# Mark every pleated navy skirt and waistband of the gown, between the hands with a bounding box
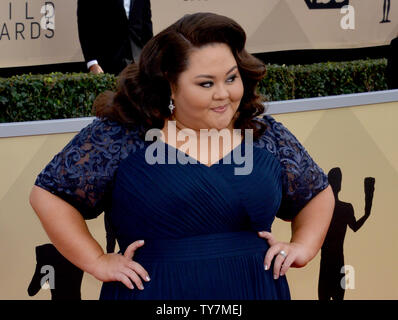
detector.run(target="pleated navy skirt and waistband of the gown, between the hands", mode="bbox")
[100,231,290,300]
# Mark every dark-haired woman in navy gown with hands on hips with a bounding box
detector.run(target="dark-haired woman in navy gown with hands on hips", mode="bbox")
[30,13,334,300]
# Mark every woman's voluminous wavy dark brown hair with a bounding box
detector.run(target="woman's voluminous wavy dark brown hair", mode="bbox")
[94,13,266,139]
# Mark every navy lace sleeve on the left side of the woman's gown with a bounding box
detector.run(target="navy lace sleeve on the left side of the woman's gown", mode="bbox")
[35,119,143,219]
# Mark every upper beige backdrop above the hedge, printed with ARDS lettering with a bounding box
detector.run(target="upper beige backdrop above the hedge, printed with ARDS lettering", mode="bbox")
[0,0,398,68]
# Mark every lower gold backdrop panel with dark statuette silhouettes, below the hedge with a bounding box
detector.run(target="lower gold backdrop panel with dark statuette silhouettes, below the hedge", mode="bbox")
[0,102,398,300]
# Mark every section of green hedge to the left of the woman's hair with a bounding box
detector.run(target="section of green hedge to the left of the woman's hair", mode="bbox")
[0,73,116,122]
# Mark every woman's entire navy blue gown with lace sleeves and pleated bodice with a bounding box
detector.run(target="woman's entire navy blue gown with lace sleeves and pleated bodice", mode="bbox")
[35,116,328,300]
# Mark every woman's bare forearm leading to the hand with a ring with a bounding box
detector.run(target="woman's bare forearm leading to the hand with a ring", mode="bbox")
[291,186,335,261]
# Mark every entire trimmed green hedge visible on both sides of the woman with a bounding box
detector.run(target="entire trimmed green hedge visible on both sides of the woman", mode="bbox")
[0,59,387,122]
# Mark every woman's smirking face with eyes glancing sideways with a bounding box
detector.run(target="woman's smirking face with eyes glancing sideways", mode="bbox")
[171,43,243,130]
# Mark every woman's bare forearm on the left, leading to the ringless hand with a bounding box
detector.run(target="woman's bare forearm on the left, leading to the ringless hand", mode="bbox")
[30,186,104,274]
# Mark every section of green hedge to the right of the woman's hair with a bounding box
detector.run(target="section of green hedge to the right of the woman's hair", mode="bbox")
[260,59,388,101]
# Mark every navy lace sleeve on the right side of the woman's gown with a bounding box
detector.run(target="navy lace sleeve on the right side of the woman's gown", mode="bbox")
[263,116,329,221]
